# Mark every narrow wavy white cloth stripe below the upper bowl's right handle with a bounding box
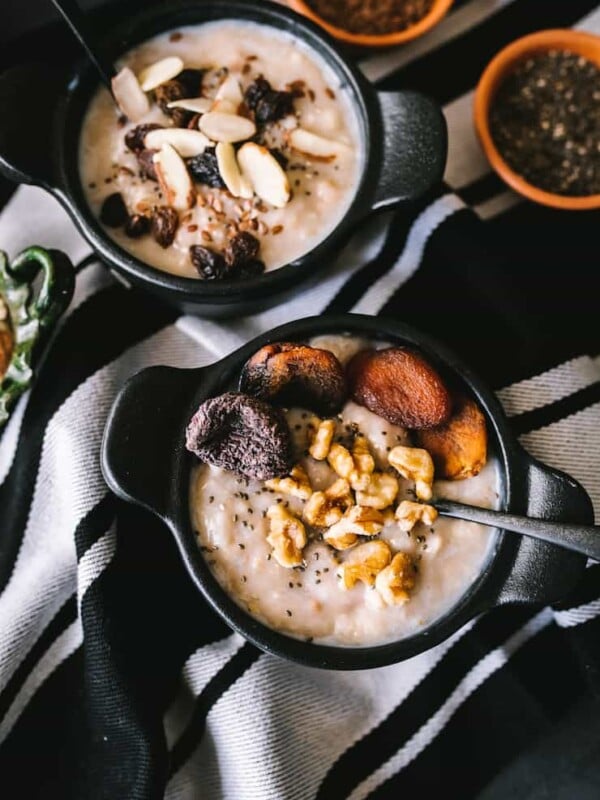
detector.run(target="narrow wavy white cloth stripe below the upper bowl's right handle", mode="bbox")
[352,194,465,314]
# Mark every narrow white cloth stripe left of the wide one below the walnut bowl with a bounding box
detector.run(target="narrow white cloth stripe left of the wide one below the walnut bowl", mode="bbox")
[164,633,245,752]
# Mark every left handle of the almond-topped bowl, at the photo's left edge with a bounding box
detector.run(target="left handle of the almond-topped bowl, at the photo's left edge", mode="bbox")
[0,64,63,190]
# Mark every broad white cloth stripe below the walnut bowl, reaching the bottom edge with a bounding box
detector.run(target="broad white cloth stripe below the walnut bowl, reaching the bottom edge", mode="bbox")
[167,621,474,800]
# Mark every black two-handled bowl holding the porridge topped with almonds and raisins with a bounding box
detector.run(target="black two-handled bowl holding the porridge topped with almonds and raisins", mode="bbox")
[0,0,447,317]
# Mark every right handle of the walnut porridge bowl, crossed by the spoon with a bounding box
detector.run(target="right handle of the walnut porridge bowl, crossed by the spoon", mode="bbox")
[498,451,594,605]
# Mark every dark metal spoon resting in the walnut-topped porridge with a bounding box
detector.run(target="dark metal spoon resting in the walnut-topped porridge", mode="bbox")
[434,500,600,561]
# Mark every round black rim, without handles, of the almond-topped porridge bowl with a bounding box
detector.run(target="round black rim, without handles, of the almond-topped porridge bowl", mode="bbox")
[56,0,382,305]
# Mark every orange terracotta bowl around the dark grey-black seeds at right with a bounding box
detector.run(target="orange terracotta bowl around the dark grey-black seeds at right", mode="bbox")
[474,29,600,211]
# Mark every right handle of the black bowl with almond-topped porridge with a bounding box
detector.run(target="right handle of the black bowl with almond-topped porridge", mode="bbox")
[372,91,448,211]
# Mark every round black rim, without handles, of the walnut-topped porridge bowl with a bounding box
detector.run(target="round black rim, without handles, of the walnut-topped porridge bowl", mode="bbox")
[165,314,519,670]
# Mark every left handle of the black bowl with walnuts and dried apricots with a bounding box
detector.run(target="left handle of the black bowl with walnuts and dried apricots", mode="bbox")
[101,367,200,519]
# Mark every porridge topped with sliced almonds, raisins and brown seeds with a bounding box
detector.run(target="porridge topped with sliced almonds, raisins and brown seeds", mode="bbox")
[79,21,362,280]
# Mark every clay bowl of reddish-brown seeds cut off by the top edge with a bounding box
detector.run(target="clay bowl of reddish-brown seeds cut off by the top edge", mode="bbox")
[289,0,453,47]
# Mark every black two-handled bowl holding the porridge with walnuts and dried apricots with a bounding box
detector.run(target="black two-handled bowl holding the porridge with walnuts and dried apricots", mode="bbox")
[102,314,594,669]
